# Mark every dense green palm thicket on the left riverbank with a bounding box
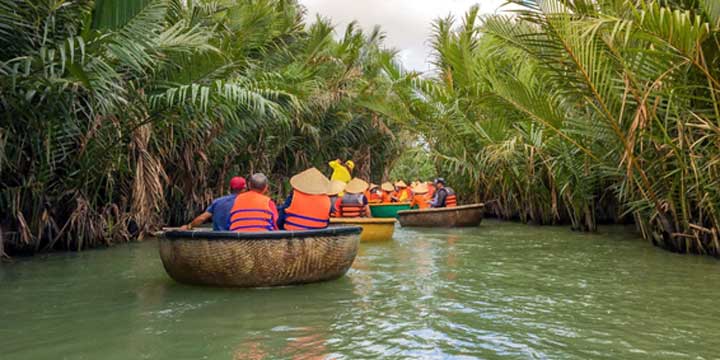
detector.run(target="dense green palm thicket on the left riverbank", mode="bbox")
[0,0,414,256]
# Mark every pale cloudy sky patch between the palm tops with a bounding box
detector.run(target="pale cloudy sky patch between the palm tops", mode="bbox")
[300,0,506,71]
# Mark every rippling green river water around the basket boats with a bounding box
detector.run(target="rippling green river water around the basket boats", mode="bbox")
[0,221,720,360]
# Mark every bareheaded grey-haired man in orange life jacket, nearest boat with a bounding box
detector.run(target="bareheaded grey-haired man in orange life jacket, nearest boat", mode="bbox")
[228,173,278,232]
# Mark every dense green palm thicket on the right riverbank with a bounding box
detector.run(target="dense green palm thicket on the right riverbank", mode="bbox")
[401,0,720,255]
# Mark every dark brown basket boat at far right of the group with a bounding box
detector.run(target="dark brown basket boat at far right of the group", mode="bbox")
[398,204,485,227]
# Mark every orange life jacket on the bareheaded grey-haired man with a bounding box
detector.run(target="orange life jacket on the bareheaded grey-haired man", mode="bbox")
[228,191,275,232]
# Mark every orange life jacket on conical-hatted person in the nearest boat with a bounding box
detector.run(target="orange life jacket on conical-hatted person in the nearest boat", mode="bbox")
[285,190,330,230]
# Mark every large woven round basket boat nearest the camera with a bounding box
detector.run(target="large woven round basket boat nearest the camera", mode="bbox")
[160,226,362,287]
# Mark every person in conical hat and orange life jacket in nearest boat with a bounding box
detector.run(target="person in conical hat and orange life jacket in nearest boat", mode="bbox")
[280,168,332,231]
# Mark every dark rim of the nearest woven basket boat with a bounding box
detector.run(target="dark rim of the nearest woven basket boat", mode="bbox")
[162,226,362,240]
